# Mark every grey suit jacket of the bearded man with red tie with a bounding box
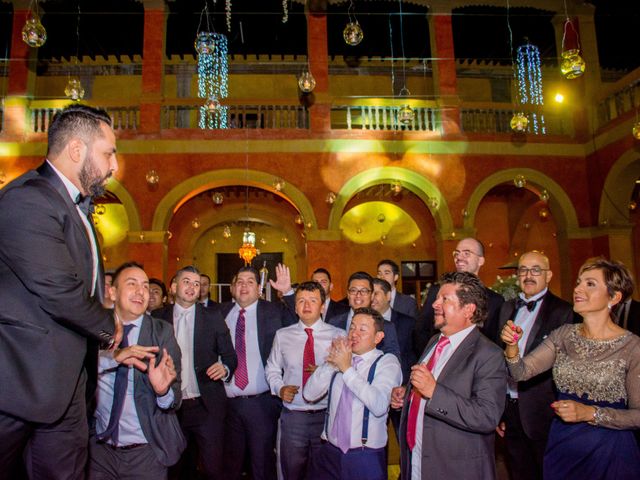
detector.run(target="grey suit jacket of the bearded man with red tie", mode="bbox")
[400,328,507,480]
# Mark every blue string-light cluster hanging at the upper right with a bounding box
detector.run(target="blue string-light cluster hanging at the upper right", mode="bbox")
[516,43,547,135]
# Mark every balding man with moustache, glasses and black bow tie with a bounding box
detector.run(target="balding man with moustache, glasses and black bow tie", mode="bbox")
[492,251,575,480]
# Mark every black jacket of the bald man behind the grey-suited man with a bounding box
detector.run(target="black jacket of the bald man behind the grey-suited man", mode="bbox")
[414,284,504,353]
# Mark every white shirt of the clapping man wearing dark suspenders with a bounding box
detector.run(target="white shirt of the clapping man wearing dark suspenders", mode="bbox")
[304,349,402,448]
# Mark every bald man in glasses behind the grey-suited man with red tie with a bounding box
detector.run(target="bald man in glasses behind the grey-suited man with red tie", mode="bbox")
[415,238,504,352]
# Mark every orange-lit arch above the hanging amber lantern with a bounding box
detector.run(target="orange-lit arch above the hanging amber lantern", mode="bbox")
[151,169,318,231]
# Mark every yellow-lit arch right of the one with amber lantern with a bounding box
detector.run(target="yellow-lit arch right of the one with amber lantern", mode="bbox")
[328,167,453,236]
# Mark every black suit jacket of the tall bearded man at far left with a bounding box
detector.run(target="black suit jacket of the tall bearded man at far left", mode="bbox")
[0,163,114,423]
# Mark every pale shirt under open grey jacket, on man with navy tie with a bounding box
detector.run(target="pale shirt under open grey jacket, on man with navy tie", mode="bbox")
[95,316,175,446]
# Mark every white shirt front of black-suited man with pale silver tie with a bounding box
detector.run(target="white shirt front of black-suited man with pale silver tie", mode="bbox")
[173,303,200,400]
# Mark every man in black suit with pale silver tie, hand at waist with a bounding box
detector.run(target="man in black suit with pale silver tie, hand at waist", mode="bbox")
[152,266,237,479]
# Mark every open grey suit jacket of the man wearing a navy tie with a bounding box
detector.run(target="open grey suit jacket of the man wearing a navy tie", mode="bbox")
[133,315,187,467]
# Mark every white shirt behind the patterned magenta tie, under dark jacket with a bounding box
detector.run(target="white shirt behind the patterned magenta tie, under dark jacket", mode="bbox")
[224,300,269,398]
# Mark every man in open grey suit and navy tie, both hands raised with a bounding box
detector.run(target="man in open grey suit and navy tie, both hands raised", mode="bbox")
[89,263,186,480]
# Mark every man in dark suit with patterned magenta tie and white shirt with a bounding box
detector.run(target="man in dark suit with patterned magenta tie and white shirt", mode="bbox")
[220,267,296,480]
